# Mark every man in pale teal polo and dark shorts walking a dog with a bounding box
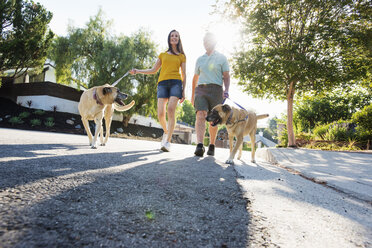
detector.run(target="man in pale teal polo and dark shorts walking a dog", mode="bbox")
[191,32,230,157]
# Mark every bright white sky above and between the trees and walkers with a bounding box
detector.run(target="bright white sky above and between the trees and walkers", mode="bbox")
[35,0,286,125]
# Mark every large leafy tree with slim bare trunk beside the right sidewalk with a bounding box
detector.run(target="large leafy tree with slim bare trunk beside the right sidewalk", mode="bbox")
[218,0,371,146]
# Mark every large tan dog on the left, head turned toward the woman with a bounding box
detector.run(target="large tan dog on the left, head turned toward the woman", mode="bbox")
[78,84,134,149]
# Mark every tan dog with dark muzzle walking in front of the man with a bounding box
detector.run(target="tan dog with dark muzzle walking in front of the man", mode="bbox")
[206,104,269,164]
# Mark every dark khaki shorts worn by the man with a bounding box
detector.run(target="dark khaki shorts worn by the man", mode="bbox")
[194,84,223,112]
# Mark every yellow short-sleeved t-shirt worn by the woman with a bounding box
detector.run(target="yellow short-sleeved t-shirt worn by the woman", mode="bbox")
[158,52,186,83]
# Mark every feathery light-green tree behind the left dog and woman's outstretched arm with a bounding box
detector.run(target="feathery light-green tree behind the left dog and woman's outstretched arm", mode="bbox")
[49,10,157,118]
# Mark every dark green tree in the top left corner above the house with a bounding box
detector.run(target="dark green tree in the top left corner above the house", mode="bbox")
[0,0,54,83]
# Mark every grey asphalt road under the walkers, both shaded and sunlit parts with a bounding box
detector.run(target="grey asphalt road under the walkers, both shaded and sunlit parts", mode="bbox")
[0,129,372,247]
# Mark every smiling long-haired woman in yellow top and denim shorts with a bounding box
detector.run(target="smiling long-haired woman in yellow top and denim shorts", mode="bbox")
[130,30,186,152]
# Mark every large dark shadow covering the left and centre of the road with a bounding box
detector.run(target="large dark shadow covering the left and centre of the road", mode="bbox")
[0,145,249,247]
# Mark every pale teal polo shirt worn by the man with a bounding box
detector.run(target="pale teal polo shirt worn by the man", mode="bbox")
[195,51,230,86]
